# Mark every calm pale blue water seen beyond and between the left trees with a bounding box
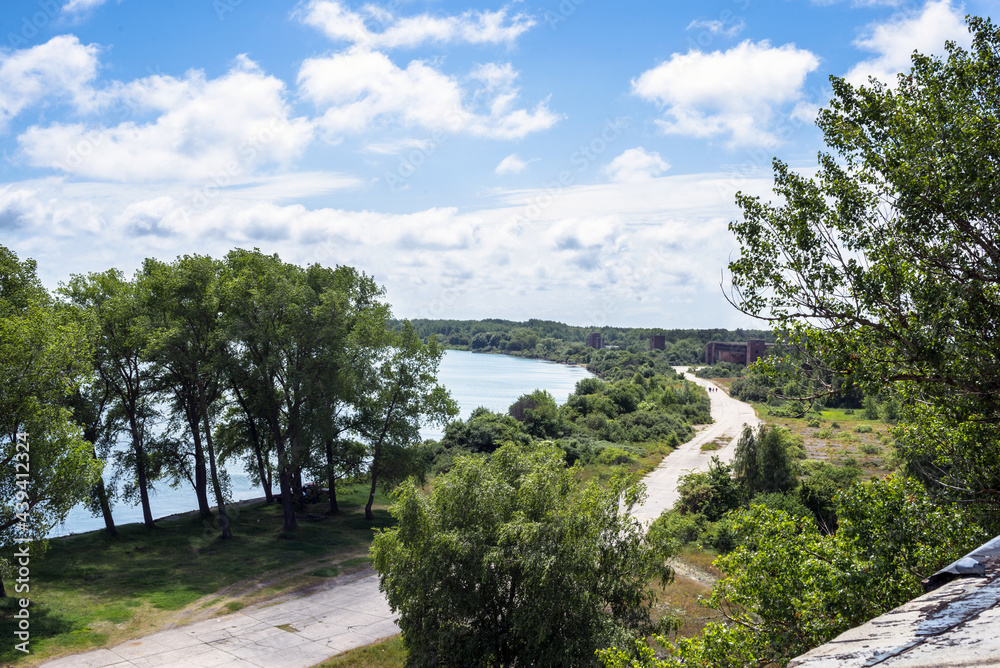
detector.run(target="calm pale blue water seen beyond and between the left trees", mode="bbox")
[51,350,592,536]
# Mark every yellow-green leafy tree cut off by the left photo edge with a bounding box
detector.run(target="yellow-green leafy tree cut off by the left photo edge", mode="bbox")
[0,246,101,597]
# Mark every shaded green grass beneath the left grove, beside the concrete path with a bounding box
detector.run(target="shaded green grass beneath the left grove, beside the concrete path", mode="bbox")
[0,485,392,666]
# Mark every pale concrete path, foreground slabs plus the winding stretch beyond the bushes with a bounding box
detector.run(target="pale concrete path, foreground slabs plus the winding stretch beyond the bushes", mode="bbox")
[42,367,757,668]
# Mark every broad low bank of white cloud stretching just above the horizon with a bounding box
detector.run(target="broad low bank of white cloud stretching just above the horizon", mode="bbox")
[11,167,772,327]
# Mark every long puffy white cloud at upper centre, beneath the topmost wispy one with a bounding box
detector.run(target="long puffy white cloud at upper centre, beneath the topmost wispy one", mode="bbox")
[298,47,560,141]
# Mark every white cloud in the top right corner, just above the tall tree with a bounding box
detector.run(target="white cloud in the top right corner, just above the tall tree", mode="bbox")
[844,0,972,85]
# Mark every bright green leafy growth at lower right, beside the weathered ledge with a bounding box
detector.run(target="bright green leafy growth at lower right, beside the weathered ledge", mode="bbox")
[602,477,989,668]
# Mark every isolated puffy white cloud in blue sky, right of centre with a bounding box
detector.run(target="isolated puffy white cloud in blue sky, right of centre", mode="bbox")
[632,40,819,146]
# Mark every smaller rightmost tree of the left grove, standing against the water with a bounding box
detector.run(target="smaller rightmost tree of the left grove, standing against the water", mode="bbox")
[354,322,458,520]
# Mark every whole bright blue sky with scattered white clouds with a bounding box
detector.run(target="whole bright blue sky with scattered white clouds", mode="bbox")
[0,0,997,328]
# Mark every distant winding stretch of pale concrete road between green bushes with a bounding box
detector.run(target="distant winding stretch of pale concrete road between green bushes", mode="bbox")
[634,367,760,524]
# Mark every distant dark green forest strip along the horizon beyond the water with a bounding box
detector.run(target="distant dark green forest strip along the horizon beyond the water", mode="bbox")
[398,318,774,365]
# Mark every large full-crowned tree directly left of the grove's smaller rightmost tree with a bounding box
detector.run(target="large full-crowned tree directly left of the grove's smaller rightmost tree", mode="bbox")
[220,250,395,530]
